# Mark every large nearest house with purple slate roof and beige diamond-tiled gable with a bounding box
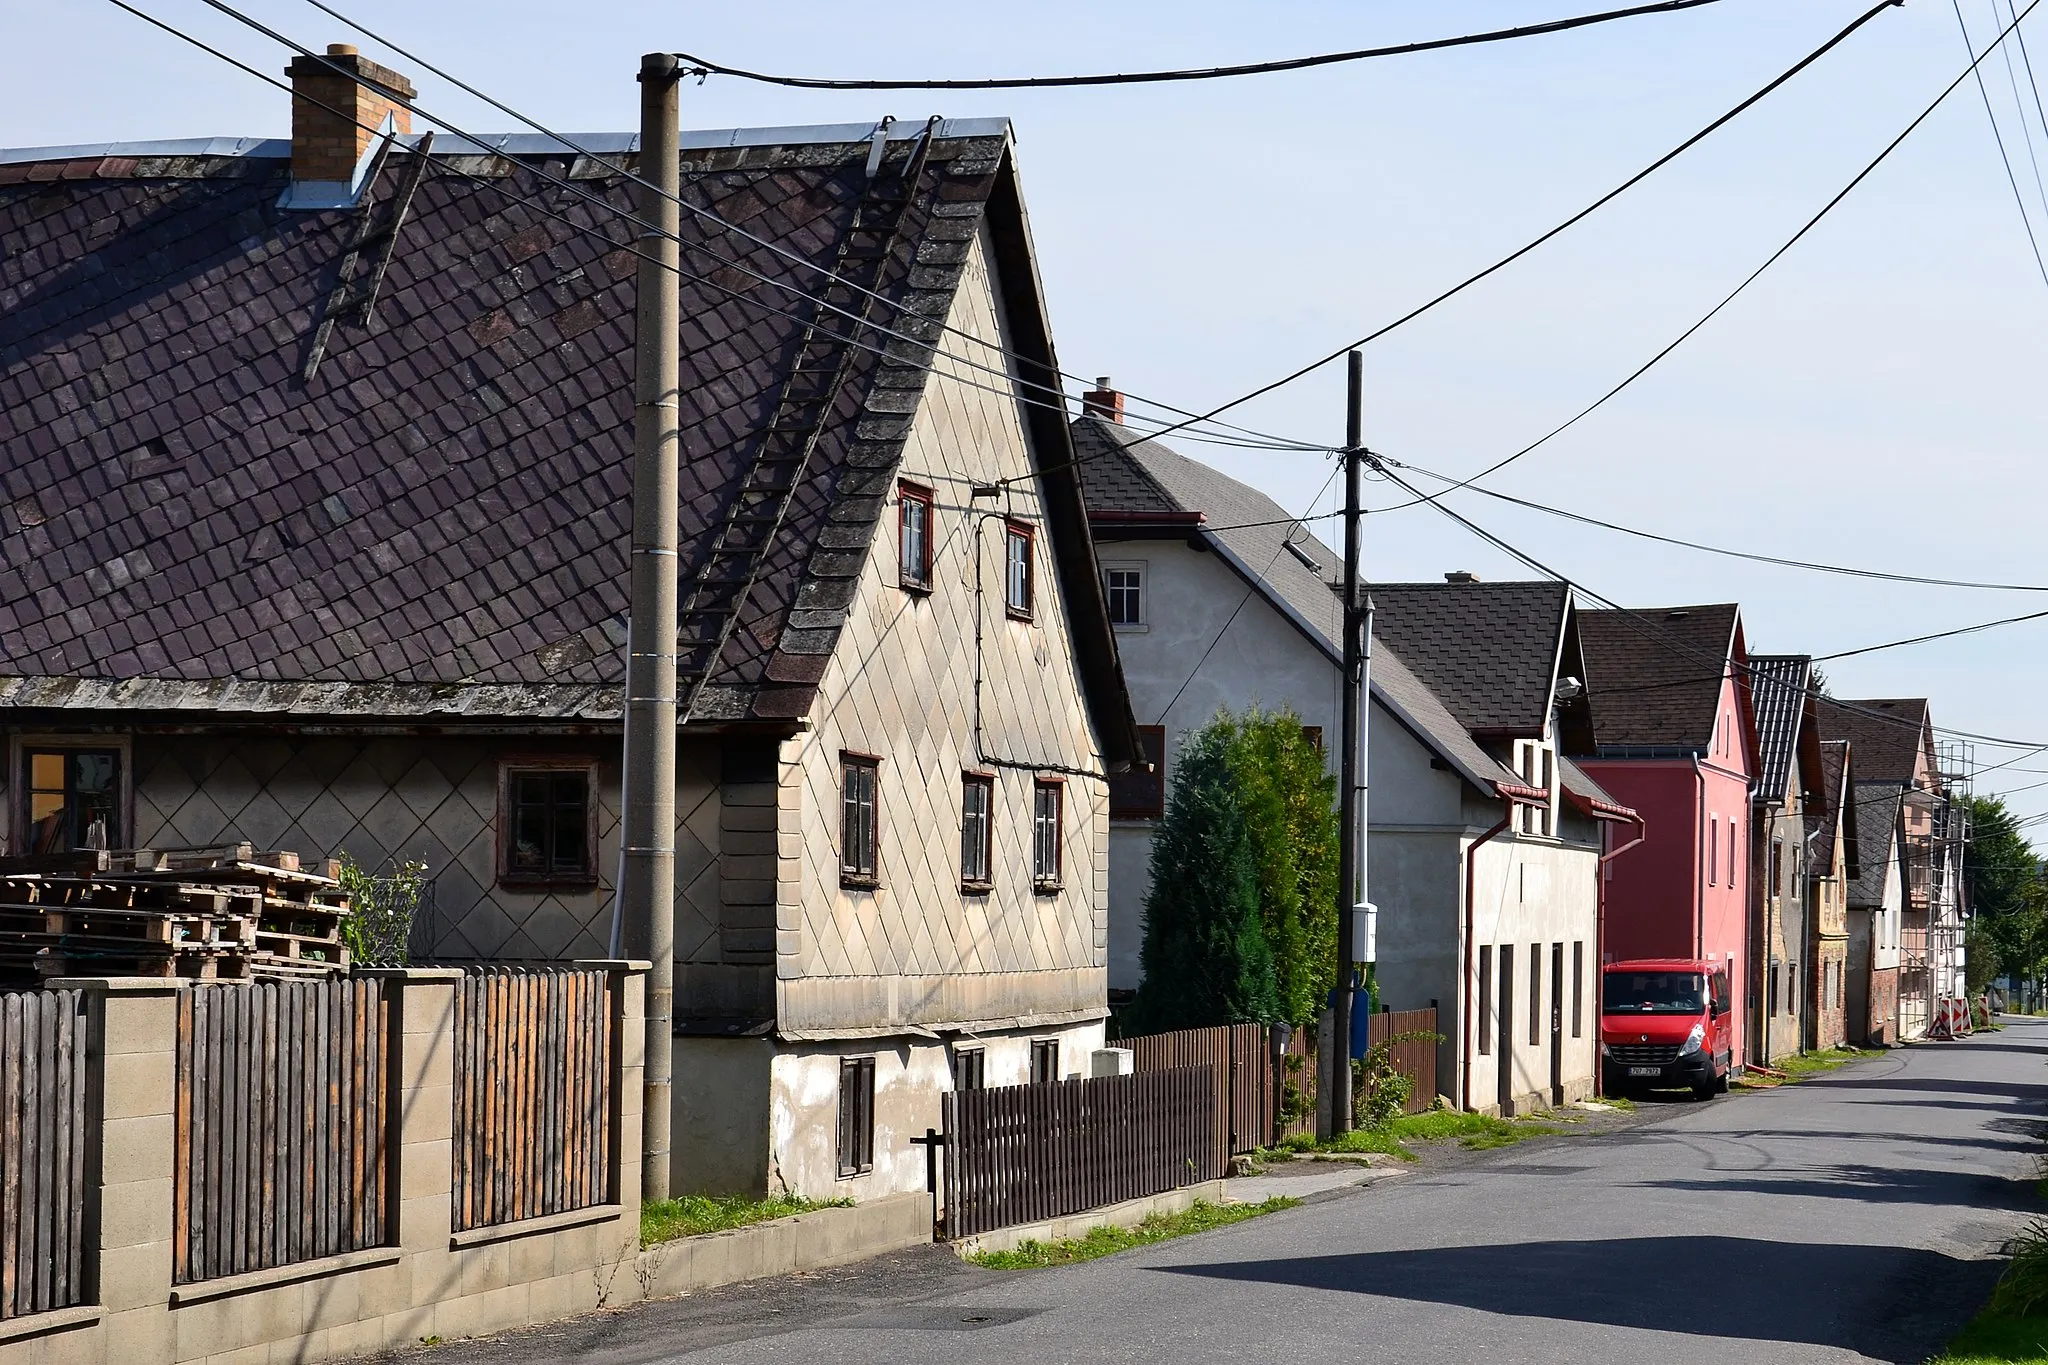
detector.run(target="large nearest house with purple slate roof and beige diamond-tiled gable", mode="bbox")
[0,49,1137,1199]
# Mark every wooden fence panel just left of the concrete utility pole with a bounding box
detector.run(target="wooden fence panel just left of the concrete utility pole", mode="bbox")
[455,968,612,1230]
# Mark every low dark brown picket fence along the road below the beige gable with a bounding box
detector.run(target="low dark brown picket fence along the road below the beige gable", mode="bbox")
[940,1066,1217,1238]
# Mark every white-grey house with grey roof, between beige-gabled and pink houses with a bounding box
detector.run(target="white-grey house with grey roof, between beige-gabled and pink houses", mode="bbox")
[1073,401,1634,1113]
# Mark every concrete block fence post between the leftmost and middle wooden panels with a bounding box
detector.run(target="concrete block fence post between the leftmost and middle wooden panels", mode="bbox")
[45,976,186,1365]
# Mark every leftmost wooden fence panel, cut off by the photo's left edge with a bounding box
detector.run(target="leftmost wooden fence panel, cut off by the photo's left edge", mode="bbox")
[0,990,92,1318]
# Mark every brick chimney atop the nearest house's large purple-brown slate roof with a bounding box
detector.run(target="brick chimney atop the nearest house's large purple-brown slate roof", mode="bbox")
[285,43,418,209]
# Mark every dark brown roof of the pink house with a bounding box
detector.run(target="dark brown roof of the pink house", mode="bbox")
[1579,604,1741,753]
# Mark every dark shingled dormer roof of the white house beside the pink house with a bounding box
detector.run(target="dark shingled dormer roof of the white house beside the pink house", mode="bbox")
[1372,581,1571,737]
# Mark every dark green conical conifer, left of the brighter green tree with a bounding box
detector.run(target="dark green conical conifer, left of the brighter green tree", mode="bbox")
[1130,718,1280,1031]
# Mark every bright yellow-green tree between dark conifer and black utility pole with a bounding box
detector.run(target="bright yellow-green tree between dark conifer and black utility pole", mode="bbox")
[1212,706,1337,1025]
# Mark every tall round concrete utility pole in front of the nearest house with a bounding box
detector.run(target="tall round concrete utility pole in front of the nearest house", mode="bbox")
[618,53,682,1199]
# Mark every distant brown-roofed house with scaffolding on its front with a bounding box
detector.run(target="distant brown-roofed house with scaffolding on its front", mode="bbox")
[1823,698,1966,1040]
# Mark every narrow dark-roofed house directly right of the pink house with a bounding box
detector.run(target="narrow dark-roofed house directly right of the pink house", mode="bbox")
[1747,655,1823,1064]
